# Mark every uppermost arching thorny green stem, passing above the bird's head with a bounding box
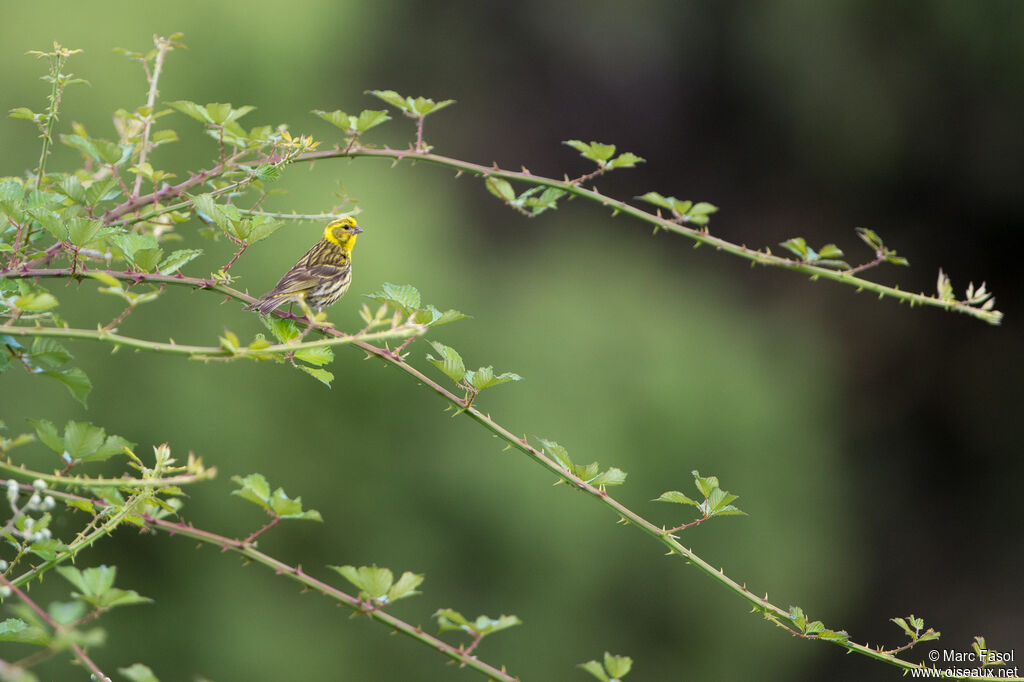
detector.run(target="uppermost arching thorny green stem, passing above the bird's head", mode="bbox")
[295,146,1002,325]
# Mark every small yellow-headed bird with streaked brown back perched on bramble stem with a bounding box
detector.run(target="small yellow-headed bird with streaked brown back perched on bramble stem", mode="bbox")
[243,216,362,317]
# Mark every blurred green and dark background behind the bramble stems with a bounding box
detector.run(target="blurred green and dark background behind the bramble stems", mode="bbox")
[0,0,1024,680]
